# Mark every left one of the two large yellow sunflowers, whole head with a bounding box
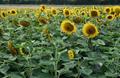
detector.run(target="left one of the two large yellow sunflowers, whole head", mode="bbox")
[61,20,77,34]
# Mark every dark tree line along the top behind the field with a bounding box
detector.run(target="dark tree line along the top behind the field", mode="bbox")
[0,0,120,5]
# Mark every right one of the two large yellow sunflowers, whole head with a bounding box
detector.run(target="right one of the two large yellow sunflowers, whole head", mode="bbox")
[82,22,99,38]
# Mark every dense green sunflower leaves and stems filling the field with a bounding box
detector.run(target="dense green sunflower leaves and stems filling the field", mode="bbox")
[0,6,120,78]
